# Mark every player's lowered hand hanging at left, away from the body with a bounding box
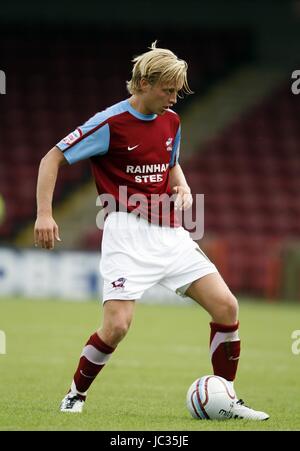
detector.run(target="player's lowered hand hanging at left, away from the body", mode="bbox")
[34,216,61,249]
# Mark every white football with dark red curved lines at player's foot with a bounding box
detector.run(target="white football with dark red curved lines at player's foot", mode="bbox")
[186,375,236,420]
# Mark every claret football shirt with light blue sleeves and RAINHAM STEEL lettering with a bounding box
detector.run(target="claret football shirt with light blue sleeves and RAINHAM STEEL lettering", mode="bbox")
[57,100,180,226]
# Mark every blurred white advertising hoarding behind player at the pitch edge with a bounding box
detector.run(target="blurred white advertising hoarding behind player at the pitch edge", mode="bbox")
[0,248,186,304]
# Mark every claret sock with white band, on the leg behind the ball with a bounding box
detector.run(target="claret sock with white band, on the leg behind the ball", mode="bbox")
[210,322,240,381]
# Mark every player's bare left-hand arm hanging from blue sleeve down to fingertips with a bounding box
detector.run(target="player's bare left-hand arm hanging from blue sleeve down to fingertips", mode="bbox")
[34,147,67,249]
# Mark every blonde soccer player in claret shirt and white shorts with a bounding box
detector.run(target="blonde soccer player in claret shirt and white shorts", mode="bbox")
[34,42,269,420]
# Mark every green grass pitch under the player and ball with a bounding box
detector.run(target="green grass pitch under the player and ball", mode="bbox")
[0,298,300,431]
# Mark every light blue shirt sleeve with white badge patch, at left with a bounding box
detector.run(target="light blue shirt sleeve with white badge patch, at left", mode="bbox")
[56,113,110,164]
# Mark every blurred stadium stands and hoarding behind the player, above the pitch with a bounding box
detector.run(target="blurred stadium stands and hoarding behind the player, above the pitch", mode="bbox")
[0,0,300,302]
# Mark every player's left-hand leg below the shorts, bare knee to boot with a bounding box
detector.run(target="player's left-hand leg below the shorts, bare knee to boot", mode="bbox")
[60,300,135,412]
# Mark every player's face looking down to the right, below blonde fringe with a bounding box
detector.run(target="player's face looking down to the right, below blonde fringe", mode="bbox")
[143,83,178,115]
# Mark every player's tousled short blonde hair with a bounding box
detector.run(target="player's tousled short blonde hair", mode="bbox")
[126,41,193,94]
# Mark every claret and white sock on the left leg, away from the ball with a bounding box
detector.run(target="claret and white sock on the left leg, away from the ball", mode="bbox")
[70,332,115,400]
